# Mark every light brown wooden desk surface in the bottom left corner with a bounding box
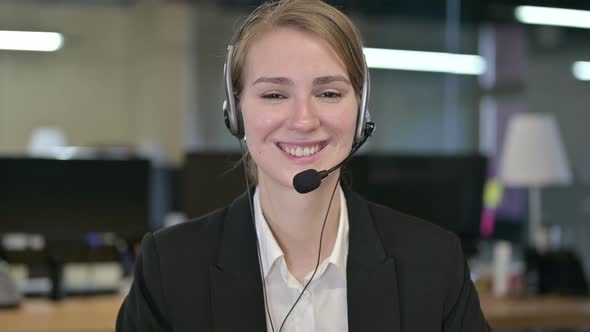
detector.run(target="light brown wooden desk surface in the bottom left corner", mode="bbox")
[0,295,124,332]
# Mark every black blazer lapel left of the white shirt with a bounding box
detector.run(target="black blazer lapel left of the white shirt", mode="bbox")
[209,193,266,332]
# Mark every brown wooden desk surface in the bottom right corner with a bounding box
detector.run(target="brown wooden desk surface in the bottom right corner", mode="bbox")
[480,295,590,329]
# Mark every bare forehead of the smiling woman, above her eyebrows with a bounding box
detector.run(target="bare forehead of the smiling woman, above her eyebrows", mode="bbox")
[244,27,348,82]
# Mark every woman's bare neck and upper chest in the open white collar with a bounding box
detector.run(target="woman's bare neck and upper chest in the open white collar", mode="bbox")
[258,171,340,279]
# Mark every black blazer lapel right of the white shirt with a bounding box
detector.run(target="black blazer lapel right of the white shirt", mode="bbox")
[345,190,400,332]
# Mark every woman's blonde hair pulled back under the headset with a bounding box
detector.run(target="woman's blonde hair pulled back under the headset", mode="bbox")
[228,0,366,183]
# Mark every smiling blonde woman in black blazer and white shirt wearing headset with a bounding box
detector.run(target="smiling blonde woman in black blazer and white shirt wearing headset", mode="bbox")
[117,0,489,332]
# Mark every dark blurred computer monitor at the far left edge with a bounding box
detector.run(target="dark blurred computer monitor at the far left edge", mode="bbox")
[0,157,150,243]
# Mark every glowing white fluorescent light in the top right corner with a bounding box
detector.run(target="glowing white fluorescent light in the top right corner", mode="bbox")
[514,6,590,29]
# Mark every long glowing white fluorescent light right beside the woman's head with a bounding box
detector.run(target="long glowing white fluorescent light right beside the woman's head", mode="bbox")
[363,47,486,75]
